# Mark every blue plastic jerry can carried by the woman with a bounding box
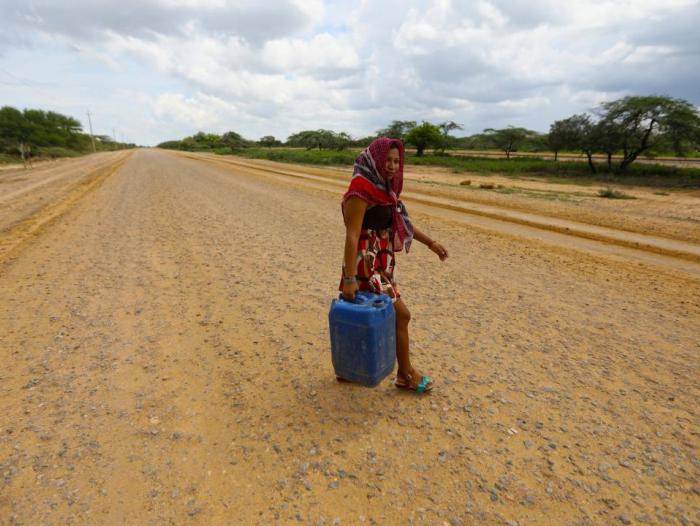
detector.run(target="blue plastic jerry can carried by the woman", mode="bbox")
[328,292,396,387]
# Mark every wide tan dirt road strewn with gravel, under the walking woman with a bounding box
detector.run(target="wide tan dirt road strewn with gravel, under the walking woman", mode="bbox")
[0,150,700,526]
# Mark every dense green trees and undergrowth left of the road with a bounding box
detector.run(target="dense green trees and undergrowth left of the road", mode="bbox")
[0,106,136,164]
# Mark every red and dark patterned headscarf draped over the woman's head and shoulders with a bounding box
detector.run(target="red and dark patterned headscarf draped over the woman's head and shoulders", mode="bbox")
[343,137,413,252]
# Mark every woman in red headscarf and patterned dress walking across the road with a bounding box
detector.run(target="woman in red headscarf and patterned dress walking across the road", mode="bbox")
[340,137,448,393]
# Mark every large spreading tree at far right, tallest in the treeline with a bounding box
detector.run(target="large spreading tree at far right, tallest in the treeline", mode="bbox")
[602,95,700,172]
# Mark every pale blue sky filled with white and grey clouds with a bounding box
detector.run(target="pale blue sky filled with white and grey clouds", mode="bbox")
[0,0,700,145]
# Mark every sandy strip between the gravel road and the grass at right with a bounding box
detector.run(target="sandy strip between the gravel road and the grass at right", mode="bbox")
[212,154,700,243]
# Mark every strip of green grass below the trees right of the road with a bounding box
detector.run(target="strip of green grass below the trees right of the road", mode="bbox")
[230,148,700,188]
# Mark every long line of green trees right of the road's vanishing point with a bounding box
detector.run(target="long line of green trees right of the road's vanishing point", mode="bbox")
[158,96,700,173]
